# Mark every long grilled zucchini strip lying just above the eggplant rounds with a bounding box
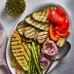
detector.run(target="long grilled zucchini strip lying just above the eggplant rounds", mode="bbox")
[25,16,49,31]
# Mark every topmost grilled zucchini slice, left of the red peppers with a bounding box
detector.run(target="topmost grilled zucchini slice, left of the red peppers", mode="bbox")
[32,6,56,23]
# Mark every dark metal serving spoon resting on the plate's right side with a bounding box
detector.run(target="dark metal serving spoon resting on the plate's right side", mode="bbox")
[44,41,71,74]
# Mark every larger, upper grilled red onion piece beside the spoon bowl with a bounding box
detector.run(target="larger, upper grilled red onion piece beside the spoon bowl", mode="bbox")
[42,40,58,59]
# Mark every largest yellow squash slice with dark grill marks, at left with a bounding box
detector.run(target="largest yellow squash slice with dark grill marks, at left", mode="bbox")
[11,31,29,71]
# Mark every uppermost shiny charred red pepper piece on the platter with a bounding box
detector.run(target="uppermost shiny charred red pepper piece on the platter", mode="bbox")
[48,10,69,26]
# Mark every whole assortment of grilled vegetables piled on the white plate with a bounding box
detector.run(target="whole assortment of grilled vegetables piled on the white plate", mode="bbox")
[6,5,70,74]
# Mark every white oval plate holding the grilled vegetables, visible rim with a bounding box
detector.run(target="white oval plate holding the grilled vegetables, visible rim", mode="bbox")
[6,2,71,74]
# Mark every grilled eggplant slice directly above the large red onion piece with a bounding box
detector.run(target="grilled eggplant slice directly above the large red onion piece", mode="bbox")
[37,31,48,43]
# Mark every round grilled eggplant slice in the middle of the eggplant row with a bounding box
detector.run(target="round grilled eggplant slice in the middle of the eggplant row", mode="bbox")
[24,26,36,39]
